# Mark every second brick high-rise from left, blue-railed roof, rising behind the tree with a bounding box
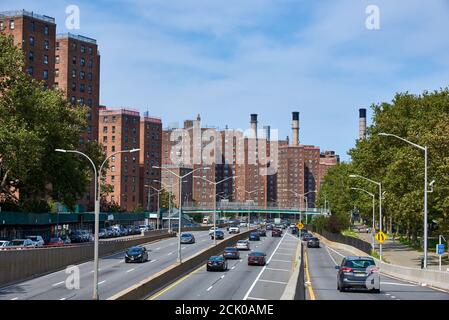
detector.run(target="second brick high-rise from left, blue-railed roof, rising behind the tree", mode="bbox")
[54,33,100,144]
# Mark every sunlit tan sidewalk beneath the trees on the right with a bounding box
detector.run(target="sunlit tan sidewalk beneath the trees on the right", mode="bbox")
[357,233,449,271]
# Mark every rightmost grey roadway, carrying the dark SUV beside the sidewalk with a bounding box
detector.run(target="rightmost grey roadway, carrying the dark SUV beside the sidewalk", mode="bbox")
[305,243,449,300]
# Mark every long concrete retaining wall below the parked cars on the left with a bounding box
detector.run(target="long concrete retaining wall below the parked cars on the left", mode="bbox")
[0,230,175,286]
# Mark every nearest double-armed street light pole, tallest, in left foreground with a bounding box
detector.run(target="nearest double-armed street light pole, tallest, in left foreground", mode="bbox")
[55,149,140,300]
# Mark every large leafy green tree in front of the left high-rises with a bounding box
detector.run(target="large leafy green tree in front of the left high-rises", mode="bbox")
[0,34,105,212]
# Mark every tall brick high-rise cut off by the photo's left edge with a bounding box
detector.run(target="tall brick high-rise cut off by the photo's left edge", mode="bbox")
[0,10,56,88]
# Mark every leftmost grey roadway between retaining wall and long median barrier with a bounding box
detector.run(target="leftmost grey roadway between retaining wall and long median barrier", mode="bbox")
[0,228,236,300]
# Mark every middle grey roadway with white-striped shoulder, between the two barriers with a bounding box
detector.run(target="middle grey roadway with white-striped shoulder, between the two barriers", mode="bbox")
[149,231,299,300]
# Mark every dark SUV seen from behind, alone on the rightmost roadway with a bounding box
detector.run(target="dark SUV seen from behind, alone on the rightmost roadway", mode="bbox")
[335,256,380,293]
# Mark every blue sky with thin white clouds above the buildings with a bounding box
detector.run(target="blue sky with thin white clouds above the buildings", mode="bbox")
[0,0,449,161]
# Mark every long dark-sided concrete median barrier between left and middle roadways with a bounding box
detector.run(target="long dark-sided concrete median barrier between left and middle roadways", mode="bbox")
[108,229,255,300]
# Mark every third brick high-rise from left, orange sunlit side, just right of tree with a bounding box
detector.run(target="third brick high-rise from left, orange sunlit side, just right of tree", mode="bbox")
[99,108,143,211]
